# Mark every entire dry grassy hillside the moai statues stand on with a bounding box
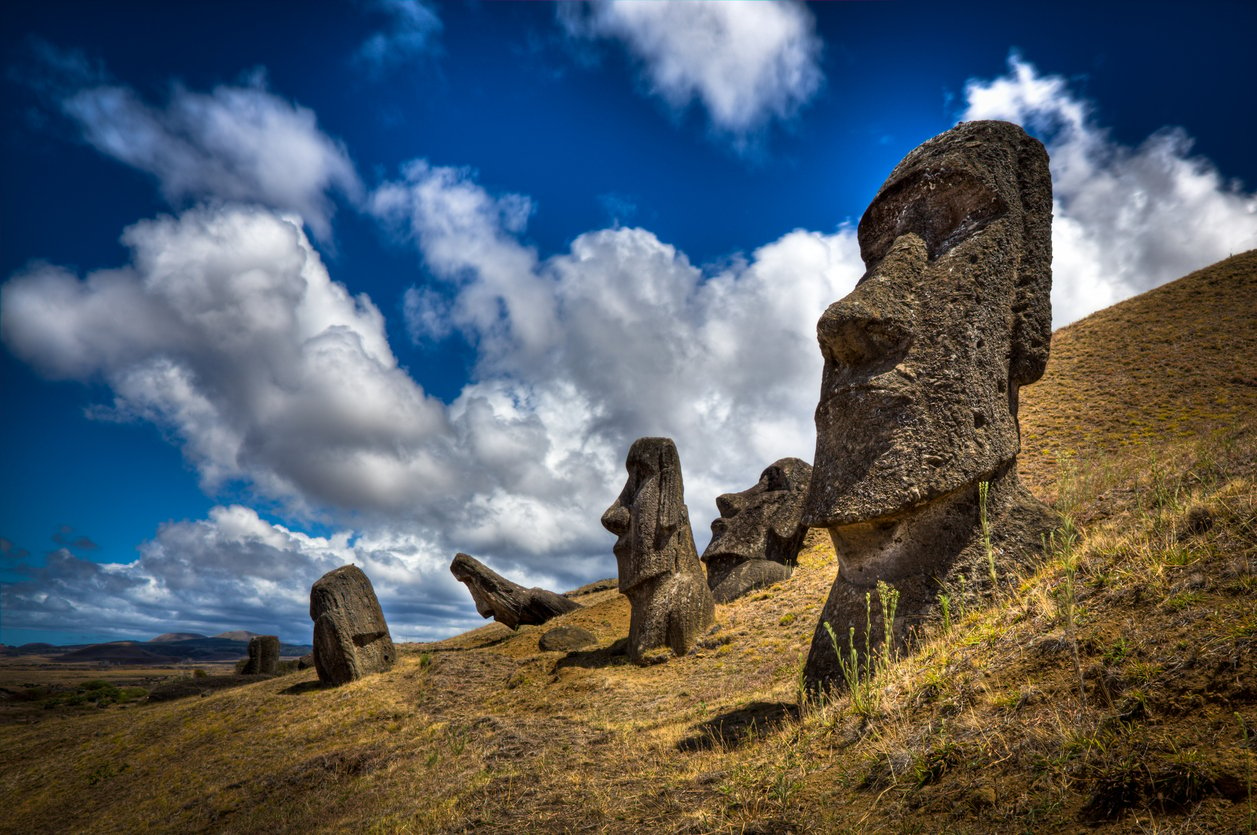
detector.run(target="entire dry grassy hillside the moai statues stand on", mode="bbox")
[0,253,1257,832]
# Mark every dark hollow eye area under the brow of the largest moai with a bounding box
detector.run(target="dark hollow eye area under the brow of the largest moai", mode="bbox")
[859,170,1008,267]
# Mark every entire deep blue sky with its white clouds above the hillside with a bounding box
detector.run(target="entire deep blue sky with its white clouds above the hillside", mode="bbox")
[0,0,1257,644]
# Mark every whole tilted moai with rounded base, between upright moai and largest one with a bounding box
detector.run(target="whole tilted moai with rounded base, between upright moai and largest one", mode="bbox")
[703,458,812,604]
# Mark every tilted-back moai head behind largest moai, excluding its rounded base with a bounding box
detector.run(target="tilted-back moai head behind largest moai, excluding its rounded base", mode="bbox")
[703,458,812,570]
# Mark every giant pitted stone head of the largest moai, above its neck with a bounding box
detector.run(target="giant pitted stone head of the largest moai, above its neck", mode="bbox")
[803,122,1052,529]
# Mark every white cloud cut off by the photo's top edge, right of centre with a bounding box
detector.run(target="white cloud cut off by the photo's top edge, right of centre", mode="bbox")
[561,0,823,135]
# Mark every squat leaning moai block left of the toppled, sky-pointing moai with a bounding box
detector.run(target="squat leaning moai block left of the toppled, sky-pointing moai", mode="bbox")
[310,566,397,684]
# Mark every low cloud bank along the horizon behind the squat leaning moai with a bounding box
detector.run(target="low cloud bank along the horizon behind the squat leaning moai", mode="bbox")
[0,506,479,643]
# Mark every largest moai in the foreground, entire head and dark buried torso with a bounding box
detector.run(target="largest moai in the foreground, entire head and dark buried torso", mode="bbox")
[803,122,1056,690]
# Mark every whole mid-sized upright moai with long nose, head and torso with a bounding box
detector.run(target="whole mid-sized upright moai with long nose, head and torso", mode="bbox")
[602,438,715,664]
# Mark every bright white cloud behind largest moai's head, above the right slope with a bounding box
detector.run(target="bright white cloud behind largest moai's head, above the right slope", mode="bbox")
[964,54,1257,327]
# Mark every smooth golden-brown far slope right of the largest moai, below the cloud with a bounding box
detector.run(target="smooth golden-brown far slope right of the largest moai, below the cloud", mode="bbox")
[1018,250,1257,499]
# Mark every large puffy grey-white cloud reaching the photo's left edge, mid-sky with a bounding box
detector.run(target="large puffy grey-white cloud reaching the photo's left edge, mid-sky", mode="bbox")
[0,206,449,509]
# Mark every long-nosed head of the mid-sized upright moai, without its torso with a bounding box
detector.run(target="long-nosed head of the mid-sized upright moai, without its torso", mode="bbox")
[602,438,698,591]
